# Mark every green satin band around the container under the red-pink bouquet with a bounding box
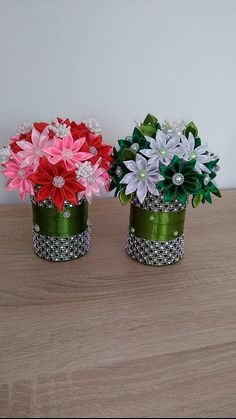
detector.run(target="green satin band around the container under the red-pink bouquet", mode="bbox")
[32,202,88,237]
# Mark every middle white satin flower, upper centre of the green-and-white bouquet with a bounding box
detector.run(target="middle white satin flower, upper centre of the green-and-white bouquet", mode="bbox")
[140,130,182,170]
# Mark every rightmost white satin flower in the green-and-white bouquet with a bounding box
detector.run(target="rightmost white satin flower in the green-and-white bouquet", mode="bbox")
[180,132,215,173]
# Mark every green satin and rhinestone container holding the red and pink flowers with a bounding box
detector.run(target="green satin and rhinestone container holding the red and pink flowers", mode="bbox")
[32,199,91,262]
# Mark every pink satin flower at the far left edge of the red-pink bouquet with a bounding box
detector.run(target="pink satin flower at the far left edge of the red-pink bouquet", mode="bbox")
[2,152,34,199]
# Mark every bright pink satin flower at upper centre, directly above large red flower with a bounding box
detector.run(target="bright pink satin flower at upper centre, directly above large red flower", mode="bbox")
[49,133,93,170]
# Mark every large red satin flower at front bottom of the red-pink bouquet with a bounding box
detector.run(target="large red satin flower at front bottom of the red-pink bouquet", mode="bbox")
[29,158,85,211]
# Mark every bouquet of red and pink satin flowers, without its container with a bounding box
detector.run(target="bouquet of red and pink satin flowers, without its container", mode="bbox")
[0,118,112,211]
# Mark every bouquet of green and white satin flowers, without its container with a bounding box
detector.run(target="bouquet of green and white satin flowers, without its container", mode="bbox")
[109,114,221,207]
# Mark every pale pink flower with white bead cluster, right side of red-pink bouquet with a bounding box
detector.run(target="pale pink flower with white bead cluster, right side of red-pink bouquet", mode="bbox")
[75,159,109,204]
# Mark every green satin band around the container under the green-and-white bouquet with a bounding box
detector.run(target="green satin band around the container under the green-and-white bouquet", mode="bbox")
[130,204,185,241]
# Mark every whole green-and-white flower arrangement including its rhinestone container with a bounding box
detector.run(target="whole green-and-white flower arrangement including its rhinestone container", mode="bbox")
[109,114,221,266]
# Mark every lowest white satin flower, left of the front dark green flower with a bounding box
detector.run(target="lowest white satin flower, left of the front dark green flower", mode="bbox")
[121,154,163,203]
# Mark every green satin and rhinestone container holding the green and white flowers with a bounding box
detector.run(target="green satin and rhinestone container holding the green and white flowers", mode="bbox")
[126,194,186,266]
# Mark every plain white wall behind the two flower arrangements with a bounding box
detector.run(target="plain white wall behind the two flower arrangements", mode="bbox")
[0,0,236,202]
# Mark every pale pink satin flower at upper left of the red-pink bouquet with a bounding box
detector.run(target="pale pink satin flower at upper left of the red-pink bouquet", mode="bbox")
[17,128,52,171]
